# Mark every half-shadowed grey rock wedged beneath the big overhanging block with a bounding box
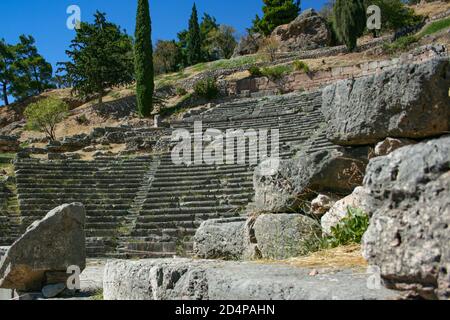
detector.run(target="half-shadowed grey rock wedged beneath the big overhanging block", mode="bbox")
[253,148,368,212]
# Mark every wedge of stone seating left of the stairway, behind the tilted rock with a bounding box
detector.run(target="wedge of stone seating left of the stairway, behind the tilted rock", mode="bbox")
[16,157,152,257]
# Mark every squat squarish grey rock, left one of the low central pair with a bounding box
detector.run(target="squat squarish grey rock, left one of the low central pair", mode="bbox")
[194,217,246,260]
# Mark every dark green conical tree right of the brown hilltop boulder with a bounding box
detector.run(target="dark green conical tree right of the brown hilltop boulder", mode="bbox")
[333,0,366,51]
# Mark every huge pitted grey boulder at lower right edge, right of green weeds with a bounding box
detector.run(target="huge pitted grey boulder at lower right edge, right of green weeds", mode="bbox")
[363,136,450,299]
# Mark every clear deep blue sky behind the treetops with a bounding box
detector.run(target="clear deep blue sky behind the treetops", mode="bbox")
[0,0,325,69]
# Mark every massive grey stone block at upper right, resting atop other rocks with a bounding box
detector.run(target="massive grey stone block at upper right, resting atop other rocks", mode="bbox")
[322,58,450,145]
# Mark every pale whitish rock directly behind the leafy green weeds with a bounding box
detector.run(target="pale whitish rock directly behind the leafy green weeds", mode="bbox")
[321,187,368,234]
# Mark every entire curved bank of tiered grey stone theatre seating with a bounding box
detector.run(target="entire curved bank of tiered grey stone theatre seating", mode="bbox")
[4,92,333,258]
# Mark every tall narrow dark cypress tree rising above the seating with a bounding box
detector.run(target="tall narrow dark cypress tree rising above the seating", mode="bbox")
[134,0,155,117]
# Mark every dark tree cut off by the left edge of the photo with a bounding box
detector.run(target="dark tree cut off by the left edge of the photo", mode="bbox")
[0,39,15,106]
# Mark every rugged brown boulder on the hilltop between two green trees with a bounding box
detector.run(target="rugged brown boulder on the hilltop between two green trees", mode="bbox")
[271,9,332,52]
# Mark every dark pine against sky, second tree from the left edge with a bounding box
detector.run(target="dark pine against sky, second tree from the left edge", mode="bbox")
[11,35,55,100]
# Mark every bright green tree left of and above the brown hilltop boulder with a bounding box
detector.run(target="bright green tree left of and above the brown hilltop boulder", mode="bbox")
[252,0,300,36]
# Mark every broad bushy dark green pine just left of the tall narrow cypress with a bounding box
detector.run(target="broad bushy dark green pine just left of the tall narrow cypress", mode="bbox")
[58,11,134,103]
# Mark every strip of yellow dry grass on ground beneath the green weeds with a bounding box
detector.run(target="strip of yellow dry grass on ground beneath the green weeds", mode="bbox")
[258,245,367,269]
